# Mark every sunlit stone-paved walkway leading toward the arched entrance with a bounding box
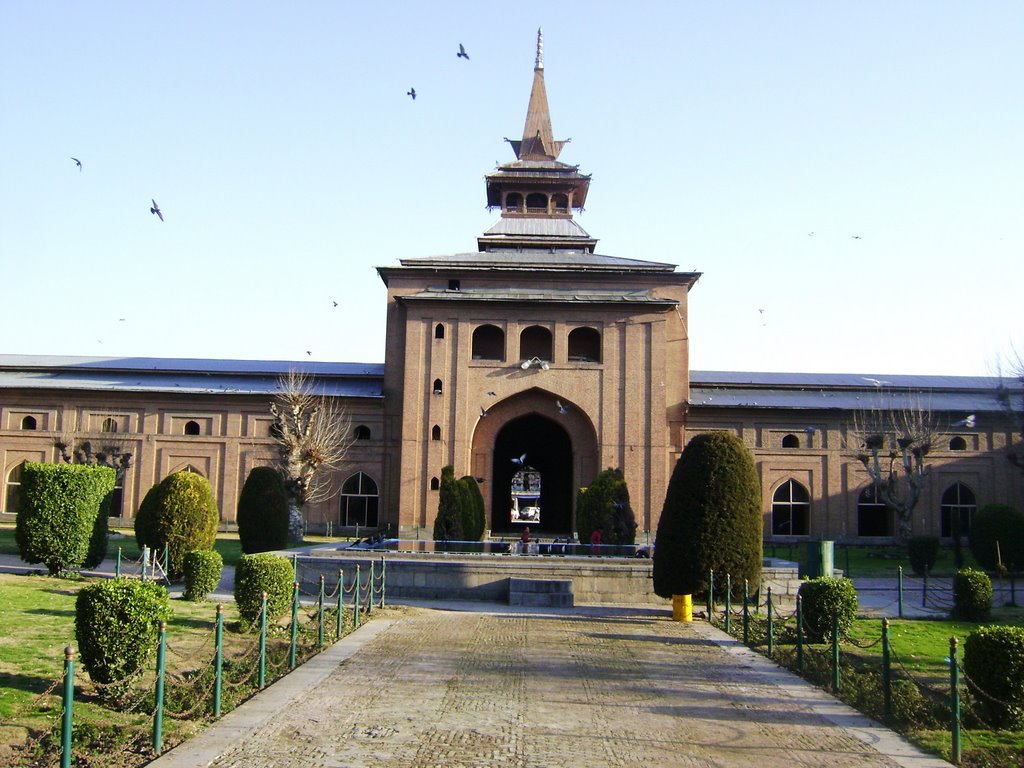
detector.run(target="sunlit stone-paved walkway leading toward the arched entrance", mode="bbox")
[152,604,948,768]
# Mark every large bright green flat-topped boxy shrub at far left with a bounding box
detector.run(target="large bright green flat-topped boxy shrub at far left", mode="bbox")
[14,463,117,574]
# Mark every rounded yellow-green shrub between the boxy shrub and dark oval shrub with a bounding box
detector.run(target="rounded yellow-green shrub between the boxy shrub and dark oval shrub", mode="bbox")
[135,470,220,579]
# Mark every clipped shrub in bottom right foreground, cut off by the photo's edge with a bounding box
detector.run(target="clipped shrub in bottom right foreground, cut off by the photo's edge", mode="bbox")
[964,627,1024,729]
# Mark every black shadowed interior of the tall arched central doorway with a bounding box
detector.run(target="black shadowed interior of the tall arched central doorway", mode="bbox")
[490,414,575,536]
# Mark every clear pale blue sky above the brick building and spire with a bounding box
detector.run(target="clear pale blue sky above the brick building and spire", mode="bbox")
[0,0,1024,375]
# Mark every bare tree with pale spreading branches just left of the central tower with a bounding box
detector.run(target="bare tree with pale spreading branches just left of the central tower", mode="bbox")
[270,370,353,542]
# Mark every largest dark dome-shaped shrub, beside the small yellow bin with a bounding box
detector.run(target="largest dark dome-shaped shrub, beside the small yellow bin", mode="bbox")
[654,432,763,597]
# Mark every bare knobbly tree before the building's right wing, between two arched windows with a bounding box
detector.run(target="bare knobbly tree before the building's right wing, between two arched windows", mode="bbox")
[847,391,945,541]
